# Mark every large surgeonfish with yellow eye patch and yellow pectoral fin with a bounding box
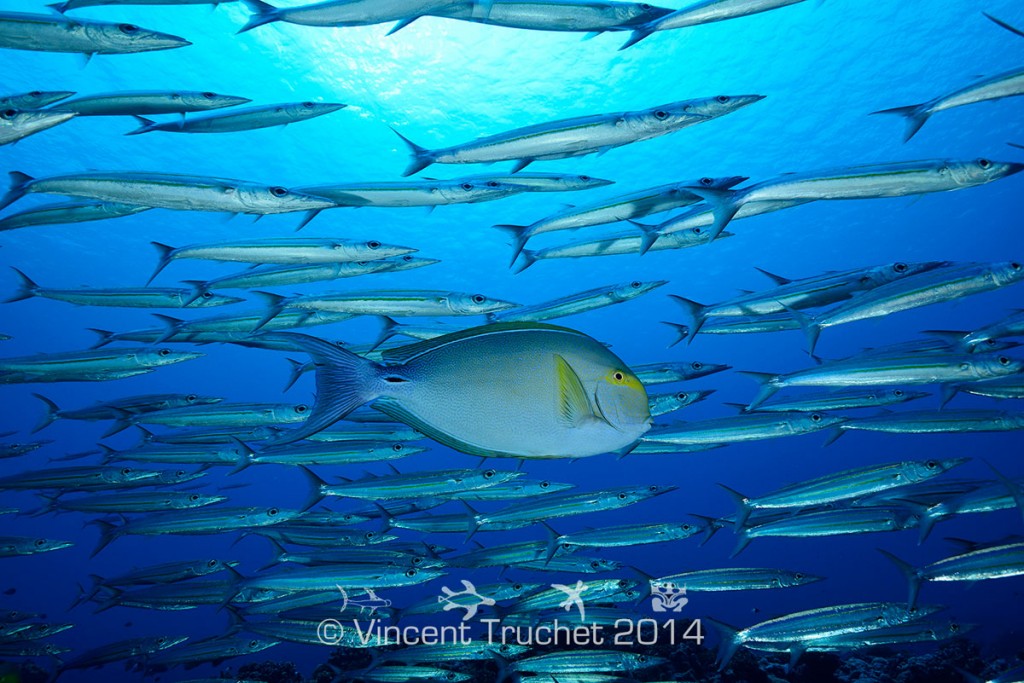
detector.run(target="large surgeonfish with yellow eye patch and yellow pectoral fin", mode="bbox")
[262,323,651,458]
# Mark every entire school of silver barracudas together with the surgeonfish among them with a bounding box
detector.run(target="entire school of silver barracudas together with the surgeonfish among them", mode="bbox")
[0,0,1024,683]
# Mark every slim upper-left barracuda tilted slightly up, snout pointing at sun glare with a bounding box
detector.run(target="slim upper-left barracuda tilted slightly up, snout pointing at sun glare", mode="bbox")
[125,102,348,135]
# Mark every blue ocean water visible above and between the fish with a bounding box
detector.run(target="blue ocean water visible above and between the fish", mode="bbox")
[0,0,1024,681]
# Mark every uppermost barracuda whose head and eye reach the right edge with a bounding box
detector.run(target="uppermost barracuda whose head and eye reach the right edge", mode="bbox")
[690,159,1024,239]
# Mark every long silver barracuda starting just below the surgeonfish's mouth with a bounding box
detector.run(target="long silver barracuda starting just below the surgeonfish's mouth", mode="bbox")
[643,413,848,446]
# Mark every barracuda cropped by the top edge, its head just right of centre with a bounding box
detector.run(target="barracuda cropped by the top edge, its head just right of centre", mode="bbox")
[431,0,672,34]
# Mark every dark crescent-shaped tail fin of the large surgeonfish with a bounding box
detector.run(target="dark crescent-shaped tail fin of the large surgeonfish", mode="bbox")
[260,333,385,445]
